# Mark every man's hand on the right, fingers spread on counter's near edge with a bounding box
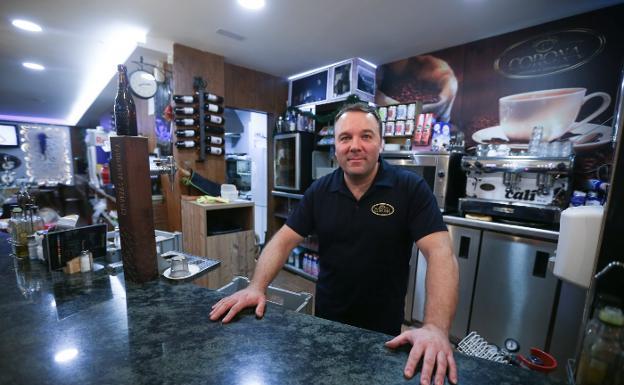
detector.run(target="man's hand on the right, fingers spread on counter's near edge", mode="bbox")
[386,324,457,385]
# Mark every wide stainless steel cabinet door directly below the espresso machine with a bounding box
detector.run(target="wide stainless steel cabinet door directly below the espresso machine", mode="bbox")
[470,231,558,353]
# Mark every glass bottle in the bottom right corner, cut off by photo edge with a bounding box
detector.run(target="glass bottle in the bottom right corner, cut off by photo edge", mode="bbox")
[576,307,624,385]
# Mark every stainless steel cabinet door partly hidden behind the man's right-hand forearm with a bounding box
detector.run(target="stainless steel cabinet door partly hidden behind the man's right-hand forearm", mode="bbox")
[412,225,481,338]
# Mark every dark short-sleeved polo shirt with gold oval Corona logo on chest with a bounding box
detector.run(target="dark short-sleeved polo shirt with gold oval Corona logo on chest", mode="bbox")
[286,160,446,335]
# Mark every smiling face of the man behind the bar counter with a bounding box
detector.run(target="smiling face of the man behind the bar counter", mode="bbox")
[335,111,382,178]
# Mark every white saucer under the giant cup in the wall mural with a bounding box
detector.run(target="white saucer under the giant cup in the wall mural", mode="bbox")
[472,123,612,151]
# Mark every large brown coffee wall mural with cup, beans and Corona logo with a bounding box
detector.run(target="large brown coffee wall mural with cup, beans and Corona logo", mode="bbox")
[375,5,624,154]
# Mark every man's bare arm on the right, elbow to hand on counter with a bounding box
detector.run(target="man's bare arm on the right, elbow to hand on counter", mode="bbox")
[386,231,459,385]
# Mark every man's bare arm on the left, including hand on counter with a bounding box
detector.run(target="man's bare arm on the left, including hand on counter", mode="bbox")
[210,225,303,323]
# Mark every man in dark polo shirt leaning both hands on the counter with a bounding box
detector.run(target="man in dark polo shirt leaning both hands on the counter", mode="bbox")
[210,104,458,385]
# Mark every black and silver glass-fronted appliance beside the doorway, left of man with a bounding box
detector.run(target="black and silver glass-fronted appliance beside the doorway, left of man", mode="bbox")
[273,131,314,194]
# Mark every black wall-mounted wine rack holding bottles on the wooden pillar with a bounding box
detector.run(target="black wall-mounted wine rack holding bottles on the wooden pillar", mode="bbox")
[174,90,225,162]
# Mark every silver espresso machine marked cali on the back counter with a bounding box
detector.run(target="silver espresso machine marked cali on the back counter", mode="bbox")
[459,156,574,227]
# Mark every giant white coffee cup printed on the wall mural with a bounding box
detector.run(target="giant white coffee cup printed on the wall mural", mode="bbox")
[498,88,611,143]
